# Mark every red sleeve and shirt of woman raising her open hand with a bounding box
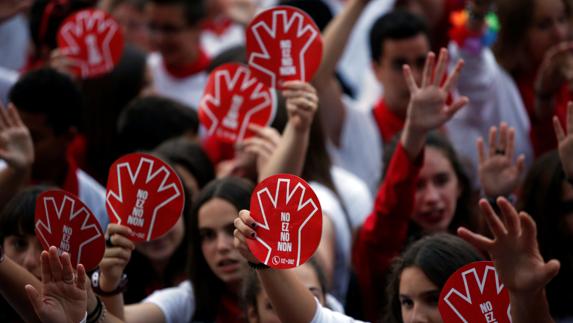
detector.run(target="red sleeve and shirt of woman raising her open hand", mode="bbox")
[352,143,424,322]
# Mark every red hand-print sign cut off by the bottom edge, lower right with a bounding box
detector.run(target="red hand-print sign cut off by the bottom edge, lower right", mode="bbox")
[438,261,511,323]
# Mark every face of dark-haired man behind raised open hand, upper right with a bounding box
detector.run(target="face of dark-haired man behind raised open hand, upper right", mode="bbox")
[373,34,430,117]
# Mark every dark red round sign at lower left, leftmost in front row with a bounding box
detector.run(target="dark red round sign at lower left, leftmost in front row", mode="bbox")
[34,190,105,270]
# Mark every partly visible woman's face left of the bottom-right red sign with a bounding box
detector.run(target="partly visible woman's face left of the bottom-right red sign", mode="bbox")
[399,267,442,323]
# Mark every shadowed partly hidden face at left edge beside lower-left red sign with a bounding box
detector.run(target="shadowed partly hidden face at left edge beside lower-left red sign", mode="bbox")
[2,234,43,279]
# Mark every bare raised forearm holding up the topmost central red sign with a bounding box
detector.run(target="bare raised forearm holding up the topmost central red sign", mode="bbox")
[259,121,310,180]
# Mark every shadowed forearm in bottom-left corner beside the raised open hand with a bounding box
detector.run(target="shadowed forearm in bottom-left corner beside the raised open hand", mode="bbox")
[0,257,42,322]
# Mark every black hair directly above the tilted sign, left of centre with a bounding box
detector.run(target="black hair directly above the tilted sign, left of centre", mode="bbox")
[118,96,199,154]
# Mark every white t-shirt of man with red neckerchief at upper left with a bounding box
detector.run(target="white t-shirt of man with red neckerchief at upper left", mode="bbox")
[147,53,209,110]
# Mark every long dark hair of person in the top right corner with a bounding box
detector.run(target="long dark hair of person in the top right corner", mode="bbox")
[493,0,571,77]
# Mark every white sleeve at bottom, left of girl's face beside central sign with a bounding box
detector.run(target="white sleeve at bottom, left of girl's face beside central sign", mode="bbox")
[143,280,195,323]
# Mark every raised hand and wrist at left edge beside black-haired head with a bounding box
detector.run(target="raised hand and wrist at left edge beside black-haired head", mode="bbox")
[0,104,34,207]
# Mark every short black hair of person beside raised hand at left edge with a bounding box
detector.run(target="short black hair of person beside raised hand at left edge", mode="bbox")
[8,68,82,135]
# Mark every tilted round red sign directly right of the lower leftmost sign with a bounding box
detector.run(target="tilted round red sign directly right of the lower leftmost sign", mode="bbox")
[106,154,185,241]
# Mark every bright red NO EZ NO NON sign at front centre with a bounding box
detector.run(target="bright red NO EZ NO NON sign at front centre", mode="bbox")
[248,174,322,269]
